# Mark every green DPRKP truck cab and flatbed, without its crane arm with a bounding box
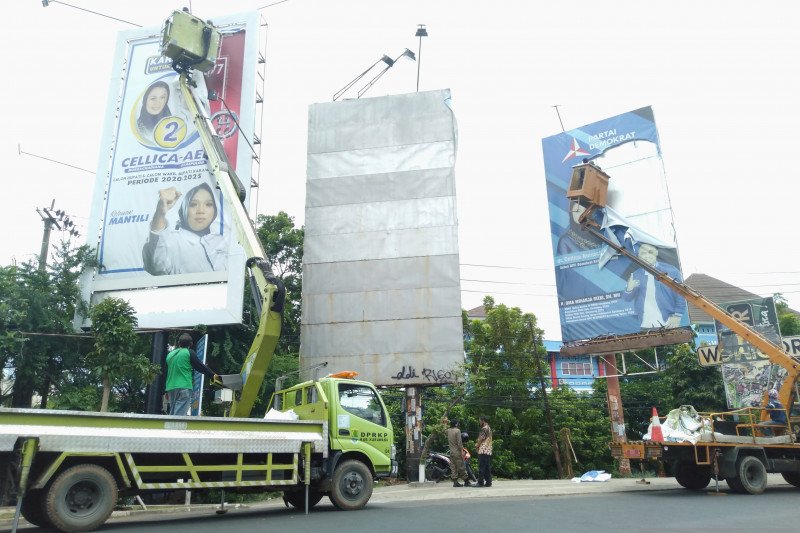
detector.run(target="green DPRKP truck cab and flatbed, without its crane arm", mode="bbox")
[0,376,397,531]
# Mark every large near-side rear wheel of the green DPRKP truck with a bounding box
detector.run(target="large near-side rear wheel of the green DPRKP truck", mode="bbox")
[45,464,117,532]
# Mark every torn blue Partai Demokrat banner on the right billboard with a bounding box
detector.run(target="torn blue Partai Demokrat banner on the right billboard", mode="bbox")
[542,107,689,342]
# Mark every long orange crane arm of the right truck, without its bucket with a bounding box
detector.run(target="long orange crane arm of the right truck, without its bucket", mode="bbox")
[581,210,800,406]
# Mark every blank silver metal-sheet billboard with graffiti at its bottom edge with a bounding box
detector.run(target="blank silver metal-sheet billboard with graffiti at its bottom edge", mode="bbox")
[300,89,464,386]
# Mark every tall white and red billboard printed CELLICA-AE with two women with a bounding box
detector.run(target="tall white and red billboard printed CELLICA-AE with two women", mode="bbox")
[76,13,258,328]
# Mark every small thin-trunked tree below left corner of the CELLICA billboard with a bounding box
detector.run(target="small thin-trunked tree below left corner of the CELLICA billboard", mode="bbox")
[88,297,161,412]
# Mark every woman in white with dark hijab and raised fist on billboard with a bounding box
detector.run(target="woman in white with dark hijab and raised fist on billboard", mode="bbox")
[142,183,230,276]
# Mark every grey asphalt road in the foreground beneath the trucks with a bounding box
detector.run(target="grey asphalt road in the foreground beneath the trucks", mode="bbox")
[6,485,800,533]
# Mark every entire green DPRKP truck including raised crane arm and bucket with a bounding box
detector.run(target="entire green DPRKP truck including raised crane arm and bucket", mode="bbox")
[0,11,397,531]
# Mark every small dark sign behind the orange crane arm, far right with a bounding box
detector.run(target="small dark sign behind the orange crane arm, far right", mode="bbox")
[717,298,786,409]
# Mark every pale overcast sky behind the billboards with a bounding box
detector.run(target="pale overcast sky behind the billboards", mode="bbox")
[0,0,800,340]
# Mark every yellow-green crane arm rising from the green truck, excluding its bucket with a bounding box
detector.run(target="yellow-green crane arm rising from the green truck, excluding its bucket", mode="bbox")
[180,70,286,417]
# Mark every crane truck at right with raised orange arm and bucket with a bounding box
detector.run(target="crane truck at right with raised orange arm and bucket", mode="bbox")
[567,161,800,494]
